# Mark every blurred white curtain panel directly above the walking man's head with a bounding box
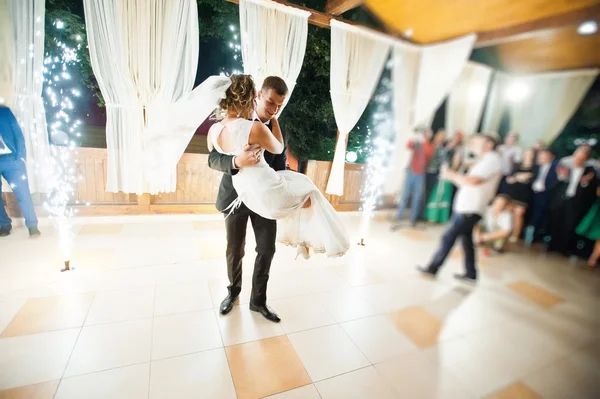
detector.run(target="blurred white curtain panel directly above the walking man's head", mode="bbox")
[446,62,494,136]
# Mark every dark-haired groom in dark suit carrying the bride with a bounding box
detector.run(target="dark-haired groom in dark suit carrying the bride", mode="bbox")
[208,76,288,323]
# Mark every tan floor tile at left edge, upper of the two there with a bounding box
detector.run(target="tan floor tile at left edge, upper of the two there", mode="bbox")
[2,294,94,338]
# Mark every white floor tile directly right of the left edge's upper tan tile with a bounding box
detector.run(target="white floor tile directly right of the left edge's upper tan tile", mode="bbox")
[85,287,154,326]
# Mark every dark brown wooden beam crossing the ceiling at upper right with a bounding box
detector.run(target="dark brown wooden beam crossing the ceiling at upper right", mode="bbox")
[475,4,600,48]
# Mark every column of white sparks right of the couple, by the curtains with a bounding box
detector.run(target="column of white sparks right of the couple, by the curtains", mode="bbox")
[359,63,394,245]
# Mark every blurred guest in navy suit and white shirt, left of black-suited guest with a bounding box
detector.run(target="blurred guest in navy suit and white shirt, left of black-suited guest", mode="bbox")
[525,148,558,245]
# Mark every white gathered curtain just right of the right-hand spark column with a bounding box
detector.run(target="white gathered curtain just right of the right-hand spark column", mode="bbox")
[384,35,477,194]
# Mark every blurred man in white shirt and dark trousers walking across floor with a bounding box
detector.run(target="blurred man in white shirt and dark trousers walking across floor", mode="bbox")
[417,133,502,281]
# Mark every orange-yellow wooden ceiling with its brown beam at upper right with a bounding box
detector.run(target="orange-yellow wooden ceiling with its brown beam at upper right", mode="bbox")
[338,0,600,73]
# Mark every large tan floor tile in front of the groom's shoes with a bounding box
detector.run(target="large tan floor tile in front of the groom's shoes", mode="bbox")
[225,336,311,399]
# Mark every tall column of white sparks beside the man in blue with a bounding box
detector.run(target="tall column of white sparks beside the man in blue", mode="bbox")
[43,20,82,270]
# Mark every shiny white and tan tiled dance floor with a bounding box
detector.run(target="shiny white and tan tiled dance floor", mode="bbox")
[0,214,600,399]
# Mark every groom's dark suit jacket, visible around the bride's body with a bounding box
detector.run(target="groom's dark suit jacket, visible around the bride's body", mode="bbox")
[208,120,287,213]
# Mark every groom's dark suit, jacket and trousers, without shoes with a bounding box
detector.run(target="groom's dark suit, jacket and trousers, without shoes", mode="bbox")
[208,120,286,306]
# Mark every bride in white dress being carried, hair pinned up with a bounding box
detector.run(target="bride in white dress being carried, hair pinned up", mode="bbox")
[207,75,350,258]
